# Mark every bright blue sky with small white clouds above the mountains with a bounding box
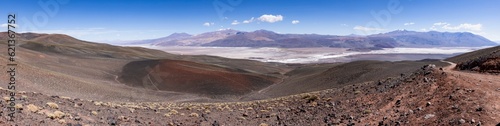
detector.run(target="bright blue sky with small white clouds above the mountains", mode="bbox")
[0,0,500,42]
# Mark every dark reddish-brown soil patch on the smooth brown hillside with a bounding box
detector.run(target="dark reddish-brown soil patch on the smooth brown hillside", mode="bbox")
[118,59,278,95]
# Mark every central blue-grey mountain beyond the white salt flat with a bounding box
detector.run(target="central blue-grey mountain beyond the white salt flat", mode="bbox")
[202,30,397,48]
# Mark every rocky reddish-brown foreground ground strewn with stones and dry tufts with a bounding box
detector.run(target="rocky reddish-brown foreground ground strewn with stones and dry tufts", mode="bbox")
[0,65,500,126]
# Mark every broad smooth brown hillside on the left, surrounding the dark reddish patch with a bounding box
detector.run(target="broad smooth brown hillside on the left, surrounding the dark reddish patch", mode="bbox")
[0,33,290,101]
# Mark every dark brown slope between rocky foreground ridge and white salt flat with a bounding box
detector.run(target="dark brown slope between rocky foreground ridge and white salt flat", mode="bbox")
[244,60,446,100]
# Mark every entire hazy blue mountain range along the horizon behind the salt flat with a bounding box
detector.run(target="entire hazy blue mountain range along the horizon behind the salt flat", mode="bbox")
[125,29,497,49]
